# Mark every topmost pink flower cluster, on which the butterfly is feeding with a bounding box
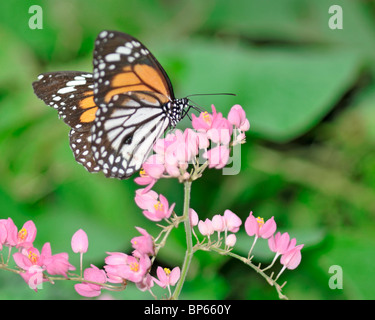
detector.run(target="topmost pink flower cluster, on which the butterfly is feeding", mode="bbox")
[135,105,250,191]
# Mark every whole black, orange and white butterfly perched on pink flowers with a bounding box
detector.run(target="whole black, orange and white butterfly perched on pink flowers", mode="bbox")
[33,31,192,179]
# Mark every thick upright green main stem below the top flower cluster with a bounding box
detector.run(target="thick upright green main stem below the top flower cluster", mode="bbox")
[171,181,193,300]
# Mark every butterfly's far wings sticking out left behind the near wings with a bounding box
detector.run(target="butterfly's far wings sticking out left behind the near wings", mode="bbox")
[33,71,101,172]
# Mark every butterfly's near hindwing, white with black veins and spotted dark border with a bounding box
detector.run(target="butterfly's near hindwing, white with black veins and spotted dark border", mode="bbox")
[91,92,169,179]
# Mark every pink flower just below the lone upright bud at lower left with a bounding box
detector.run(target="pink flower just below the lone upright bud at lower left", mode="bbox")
[74,264,107,297]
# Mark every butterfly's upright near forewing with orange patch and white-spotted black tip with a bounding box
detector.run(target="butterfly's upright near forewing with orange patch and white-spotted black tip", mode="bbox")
[93,31,174,105]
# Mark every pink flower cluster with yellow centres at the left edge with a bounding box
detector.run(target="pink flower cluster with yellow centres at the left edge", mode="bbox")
[0,218,75,291]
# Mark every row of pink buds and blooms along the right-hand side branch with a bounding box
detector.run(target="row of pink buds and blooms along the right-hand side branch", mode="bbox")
[189,209,304,270]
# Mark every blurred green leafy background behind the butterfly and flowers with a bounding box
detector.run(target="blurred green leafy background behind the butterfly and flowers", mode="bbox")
[0,0,375,299]
